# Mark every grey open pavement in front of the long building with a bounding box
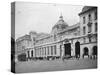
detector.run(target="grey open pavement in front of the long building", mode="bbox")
[16,58,97,73]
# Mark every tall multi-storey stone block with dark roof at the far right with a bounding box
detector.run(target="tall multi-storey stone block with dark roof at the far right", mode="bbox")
[79,6,97,56]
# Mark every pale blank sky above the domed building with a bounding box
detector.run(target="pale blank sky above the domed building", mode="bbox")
[15,2,83,39]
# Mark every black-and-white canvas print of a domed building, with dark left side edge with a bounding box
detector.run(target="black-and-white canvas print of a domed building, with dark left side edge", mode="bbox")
[11,1,98,73]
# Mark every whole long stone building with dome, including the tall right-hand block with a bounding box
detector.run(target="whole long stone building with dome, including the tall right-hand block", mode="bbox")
[16,6,97,59]
